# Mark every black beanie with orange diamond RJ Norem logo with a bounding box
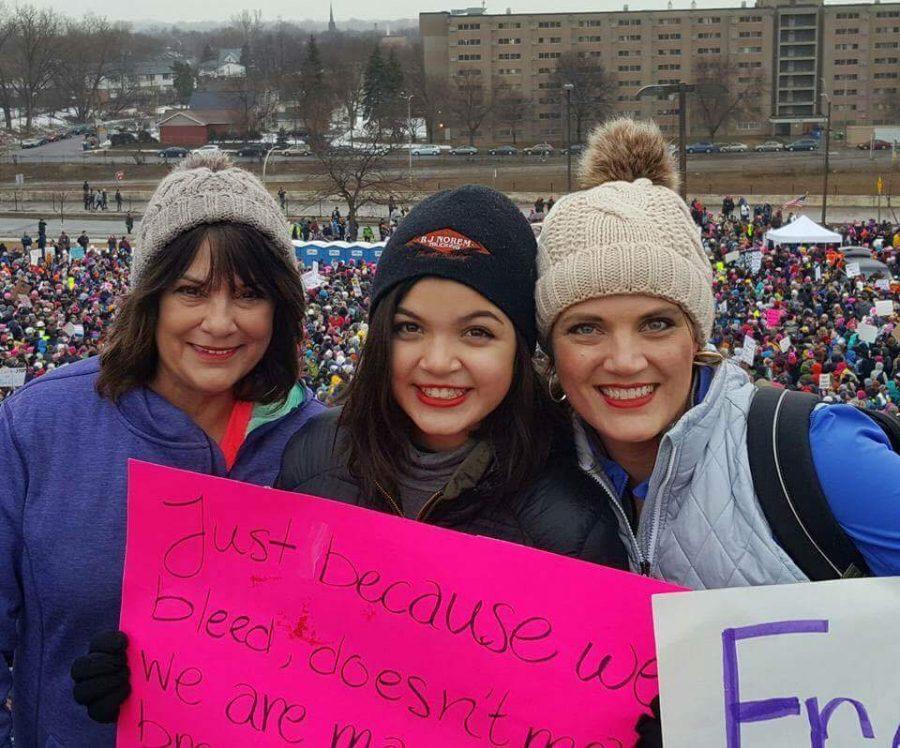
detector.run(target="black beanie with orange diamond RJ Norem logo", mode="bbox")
[369,185,537,351]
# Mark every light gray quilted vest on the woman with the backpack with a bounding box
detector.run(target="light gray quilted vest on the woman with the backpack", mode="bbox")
[575,362,808,590]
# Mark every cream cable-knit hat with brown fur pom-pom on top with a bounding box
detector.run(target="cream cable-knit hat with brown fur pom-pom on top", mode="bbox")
[535,118,715,345]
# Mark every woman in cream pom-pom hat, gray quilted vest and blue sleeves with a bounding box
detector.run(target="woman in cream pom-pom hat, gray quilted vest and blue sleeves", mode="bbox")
[536,119,900,589]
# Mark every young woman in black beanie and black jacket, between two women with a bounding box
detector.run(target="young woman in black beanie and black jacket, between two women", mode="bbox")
[276,186,623,565]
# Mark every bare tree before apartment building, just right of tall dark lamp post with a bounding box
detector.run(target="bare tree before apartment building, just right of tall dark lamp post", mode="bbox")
[690,60,765,140]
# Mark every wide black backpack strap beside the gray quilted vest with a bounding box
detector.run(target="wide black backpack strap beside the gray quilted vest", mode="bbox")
[747,387,870,581]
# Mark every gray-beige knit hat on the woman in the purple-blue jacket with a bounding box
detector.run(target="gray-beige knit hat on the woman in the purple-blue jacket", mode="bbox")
[131,152,294,286]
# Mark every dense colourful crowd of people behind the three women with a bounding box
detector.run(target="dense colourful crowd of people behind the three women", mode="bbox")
[0,205,900,413]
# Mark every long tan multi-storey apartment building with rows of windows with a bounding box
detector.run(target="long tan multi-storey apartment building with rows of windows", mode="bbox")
[419,0,900,144]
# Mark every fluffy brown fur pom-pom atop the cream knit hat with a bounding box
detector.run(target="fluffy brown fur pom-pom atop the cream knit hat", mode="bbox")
[578,117,678,190]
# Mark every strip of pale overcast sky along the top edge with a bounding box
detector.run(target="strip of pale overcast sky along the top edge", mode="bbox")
[32,0,872,23]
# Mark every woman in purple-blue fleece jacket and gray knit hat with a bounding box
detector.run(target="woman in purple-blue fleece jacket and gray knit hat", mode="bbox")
[0,154,321,746]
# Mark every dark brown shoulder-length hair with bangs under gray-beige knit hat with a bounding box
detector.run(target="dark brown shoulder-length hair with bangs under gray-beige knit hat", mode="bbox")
[97,223,305,403]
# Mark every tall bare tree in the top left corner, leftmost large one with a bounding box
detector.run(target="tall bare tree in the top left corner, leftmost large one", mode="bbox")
[10,5,61,130]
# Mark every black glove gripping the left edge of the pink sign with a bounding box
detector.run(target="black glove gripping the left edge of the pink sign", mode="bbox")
[72,631,131,722]
